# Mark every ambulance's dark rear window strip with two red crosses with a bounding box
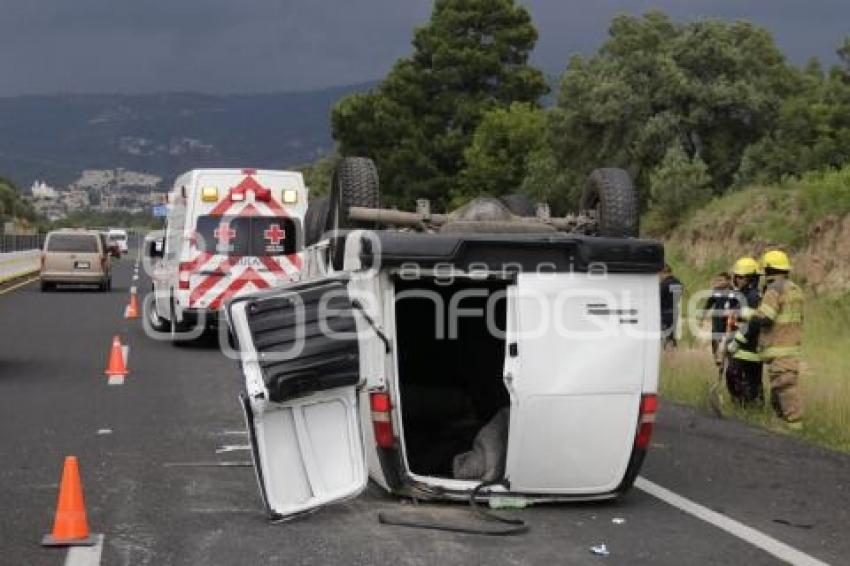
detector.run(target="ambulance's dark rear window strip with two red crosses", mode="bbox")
[195,215,298,256]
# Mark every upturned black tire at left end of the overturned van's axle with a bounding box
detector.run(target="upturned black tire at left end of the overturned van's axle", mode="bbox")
[328,157,381,229]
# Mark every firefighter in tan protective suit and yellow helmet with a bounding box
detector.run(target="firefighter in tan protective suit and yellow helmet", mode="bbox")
[741,250,804,429]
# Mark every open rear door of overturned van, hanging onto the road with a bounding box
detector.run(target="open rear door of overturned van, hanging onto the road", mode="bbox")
[227,279,368,519]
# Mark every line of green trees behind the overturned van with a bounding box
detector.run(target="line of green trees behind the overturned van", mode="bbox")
[331,0,850,231]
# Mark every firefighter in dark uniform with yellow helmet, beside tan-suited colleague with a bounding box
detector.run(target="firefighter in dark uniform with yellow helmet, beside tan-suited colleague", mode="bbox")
[724,257,764,405]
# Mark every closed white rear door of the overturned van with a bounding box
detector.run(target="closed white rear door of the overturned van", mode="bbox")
[505,273,659,494]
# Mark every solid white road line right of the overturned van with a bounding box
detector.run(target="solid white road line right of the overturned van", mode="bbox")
[635,482,827,566]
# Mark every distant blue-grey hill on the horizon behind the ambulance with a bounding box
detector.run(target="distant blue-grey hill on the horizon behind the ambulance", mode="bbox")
[0,83,373,187]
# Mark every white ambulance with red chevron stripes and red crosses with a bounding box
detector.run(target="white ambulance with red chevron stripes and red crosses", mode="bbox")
[145,169,307,341]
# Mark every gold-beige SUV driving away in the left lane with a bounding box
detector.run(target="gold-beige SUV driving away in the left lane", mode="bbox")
[41,230,112,291]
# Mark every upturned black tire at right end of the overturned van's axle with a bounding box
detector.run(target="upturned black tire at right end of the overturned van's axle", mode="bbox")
[581,167,640,238]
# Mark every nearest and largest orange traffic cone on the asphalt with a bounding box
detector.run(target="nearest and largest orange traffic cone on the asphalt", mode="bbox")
[41,456,97,546]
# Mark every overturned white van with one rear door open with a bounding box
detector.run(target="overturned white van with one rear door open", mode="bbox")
[226,158,663,519]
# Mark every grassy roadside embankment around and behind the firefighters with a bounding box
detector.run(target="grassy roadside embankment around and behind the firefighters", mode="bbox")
[661,169,850,452]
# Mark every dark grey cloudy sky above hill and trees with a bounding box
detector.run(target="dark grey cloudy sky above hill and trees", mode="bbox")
[0,0,850,96]
